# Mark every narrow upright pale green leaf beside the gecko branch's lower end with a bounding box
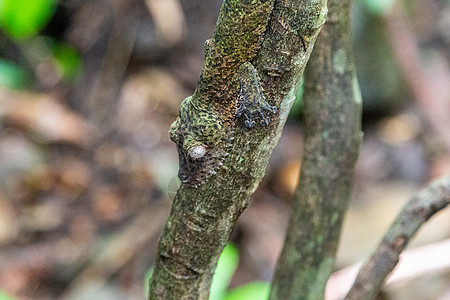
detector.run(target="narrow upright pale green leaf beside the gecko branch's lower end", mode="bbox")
[209,244,239,300]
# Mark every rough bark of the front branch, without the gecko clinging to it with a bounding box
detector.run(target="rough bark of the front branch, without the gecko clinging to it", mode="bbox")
[149,0,326,300]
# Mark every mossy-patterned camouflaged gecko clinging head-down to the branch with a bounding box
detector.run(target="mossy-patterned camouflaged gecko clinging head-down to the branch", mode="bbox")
[170,0,276,187]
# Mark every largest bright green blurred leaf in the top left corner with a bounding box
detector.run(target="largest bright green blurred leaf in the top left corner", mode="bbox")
[0,0,57,40]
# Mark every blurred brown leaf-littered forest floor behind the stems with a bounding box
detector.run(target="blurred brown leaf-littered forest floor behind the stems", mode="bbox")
[0,0,450,300]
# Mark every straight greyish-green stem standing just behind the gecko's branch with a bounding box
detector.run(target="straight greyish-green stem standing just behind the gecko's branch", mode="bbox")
[270,0,362,300]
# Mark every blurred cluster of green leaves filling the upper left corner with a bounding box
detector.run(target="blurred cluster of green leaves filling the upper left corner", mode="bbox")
[0,0,81,89]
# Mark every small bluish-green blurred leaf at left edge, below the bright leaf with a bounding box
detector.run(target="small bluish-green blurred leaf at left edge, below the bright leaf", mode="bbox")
[0,59,30,88]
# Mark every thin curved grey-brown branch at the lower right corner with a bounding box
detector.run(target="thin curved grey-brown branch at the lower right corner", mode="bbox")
[345,176,450,300]
